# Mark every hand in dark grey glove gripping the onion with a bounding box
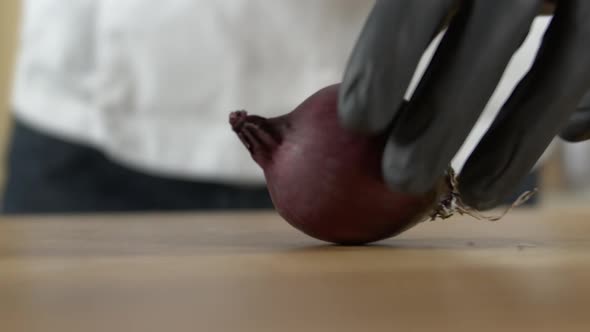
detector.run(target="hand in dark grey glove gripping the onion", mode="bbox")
[339,0,590,210]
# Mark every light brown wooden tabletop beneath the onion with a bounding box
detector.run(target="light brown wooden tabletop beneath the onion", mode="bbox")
[0,206,590,332]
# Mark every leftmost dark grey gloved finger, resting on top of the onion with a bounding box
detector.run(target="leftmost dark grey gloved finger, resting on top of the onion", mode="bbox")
[339,0,456,133]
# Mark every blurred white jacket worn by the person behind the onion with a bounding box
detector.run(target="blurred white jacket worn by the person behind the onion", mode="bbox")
[12,0,556,184]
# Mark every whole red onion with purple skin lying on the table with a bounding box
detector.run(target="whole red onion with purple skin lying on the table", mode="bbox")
[230,84,444,245]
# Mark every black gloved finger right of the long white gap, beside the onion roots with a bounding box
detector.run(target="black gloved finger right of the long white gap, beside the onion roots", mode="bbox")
[459,0,590,209]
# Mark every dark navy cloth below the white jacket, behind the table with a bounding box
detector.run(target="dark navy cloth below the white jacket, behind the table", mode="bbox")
[0,120,272,214]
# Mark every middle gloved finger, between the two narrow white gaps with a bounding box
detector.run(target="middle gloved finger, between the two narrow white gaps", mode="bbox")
[383,0,542,193]
